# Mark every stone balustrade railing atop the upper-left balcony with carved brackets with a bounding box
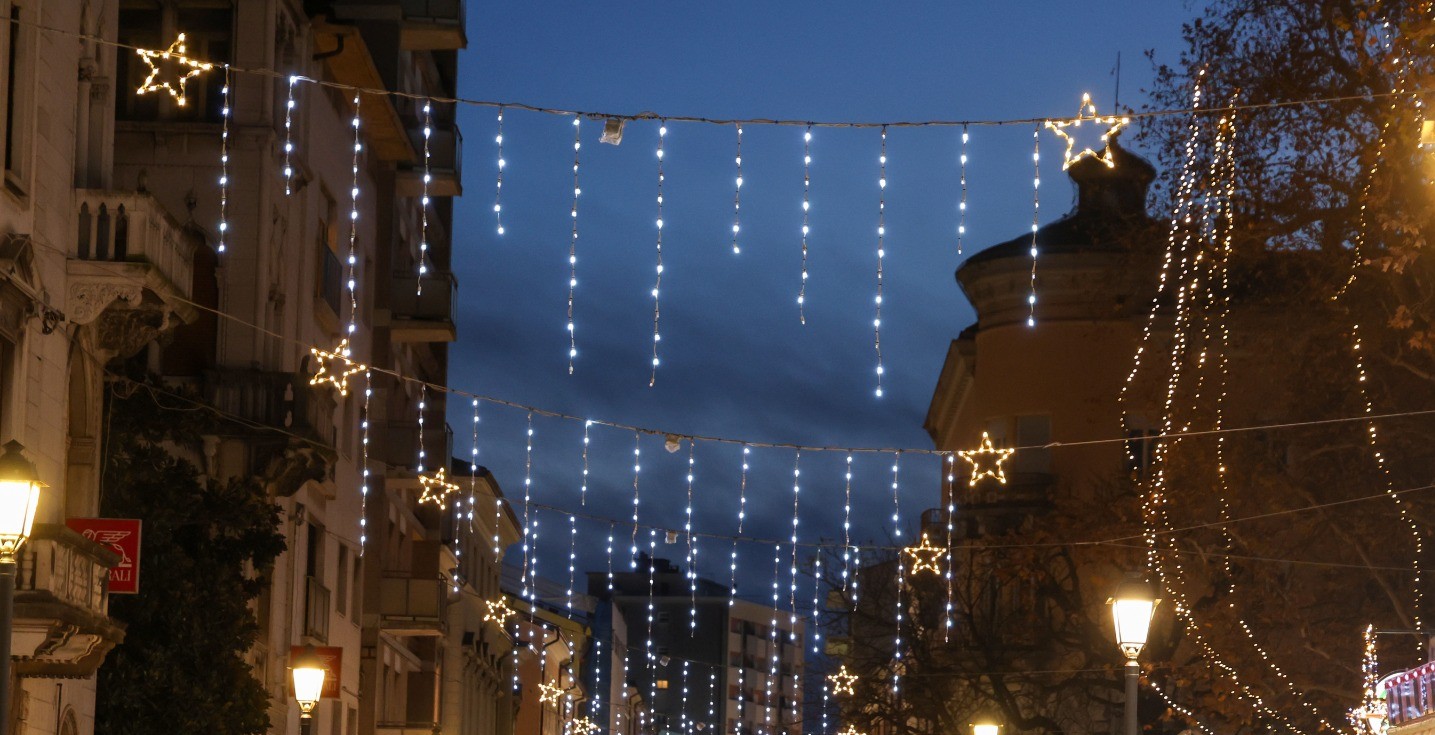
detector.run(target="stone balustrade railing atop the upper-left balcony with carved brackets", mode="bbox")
[75,189,194,299]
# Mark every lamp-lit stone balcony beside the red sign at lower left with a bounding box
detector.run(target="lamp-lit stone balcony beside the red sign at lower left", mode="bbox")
[11,524,125,678]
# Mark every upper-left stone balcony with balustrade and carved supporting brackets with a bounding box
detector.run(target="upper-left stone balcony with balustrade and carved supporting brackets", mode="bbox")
[65,189,199,355]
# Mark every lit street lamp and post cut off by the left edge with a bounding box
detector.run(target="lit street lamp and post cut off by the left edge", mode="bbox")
[0,439,44,735]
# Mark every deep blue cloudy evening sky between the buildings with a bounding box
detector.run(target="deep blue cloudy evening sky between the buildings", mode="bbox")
[448,0,1194,597]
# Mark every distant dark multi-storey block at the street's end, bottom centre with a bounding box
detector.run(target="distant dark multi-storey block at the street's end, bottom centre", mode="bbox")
[588,554,805,735]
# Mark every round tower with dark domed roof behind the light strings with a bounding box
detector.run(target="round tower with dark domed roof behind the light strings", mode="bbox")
[926,142,1164,534]
